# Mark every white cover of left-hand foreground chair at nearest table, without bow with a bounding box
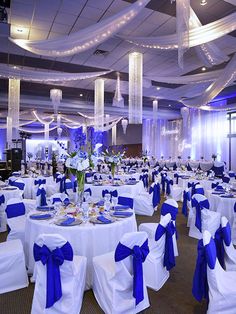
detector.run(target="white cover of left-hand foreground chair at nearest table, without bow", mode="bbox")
[31,234,87,314]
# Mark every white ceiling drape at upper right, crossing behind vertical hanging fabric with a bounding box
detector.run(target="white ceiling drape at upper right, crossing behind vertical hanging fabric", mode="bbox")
[120,12,236,50]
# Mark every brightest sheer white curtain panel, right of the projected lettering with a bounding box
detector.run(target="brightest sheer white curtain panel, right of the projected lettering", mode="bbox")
[190,109,229,162]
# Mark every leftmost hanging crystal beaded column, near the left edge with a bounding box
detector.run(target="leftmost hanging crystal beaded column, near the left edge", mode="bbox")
[8,79,20,138]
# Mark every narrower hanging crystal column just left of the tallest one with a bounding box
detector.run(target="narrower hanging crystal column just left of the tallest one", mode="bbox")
[94,79,104,131]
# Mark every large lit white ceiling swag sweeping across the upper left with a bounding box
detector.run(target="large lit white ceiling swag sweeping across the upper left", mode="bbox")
[9,0,150,57]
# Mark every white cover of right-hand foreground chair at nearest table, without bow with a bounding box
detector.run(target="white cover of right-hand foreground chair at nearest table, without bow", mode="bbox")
[93,232,149,314]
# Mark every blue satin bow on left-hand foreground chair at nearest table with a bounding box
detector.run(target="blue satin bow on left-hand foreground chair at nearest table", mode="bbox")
[34,242,73,308]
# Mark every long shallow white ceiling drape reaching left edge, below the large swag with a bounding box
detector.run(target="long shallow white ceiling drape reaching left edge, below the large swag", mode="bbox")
[0,64,111,82]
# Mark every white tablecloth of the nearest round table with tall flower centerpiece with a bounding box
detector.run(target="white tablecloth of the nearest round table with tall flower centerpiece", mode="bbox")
[25,212,137,289]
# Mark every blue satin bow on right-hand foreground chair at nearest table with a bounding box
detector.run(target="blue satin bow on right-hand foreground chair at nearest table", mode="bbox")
[115,239,149,305]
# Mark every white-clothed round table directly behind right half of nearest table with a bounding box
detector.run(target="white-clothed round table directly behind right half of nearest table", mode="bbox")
[84,181,145,198]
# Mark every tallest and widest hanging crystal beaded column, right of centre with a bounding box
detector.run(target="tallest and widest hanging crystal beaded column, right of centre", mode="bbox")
[129,52,143,124]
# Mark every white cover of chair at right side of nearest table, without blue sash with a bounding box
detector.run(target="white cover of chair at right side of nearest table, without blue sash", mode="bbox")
[139,214,171,291]
